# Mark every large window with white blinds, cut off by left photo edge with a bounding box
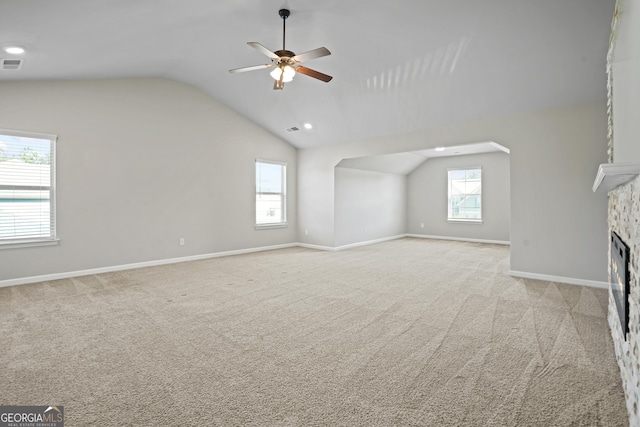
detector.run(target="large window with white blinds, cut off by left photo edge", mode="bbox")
[0,129,56,245]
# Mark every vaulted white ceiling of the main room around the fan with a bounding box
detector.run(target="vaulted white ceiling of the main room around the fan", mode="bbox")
[0,0,614,147]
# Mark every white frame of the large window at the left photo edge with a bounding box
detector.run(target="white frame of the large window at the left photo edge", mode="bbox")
[0,129,60,249]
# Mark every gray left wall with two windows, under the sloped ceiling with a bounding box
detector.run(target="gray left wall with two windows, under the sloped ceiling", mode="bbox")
[0,79,297,280]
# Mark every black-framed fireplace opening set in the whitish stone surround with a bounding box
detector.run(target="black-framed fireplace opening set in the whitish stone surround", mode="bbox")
[609,231,629,340]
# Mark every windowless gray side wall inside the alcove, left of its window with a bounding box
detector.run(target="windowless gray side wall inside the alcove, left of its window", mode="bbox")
[335,167,407,246]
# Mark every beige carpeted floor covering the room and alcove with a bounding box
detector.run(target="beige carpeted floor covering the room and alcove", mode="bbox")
[0,238,627,427]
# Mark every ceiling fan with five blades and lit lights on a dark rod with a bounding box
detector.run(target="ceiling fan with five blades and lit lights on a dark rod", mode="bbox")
[229,9,333,90]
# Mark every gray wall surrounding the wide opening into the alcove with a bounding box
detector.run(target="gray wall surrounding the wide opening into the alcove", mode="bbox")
[298,100,608,282]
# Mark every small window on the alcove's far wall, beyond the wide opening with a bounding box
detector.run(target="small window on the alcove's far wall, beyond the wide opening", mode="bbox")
[448,167,482,222]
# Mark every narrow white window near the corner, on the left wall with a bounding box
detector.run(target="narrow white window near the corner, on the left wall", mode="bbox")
[256,160,287,227]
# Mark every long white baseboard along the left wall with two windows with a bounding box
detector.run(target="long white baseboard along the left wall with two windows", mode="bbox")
[0,243,298,288]
